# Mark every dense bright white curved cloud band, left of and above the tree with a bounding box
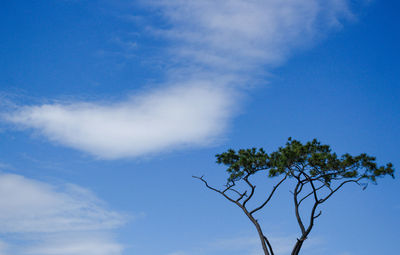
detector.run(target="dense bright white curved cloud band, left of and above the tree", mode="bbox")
[6,82,233,159]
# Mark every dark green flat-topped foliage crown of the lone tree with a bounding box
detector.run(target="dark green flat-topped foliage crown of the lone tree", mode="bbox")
[216,138,394,185]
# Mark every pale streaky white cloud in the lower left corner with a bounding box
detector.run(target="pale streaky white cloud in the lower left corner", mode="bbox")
[0,174,124,255]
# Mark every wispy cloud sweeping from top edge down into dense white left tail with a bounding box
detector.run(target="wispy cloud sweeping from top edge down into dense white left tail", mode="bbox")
[5,0,352,159]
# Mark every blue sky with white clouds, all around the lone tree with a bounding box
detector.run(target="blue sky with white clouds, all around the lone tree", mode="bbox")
[0,0,400,255]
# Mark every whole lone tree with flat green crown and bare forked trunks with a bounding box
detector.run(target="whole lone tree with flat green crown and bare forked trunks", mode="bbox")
[193,138,394,255]
